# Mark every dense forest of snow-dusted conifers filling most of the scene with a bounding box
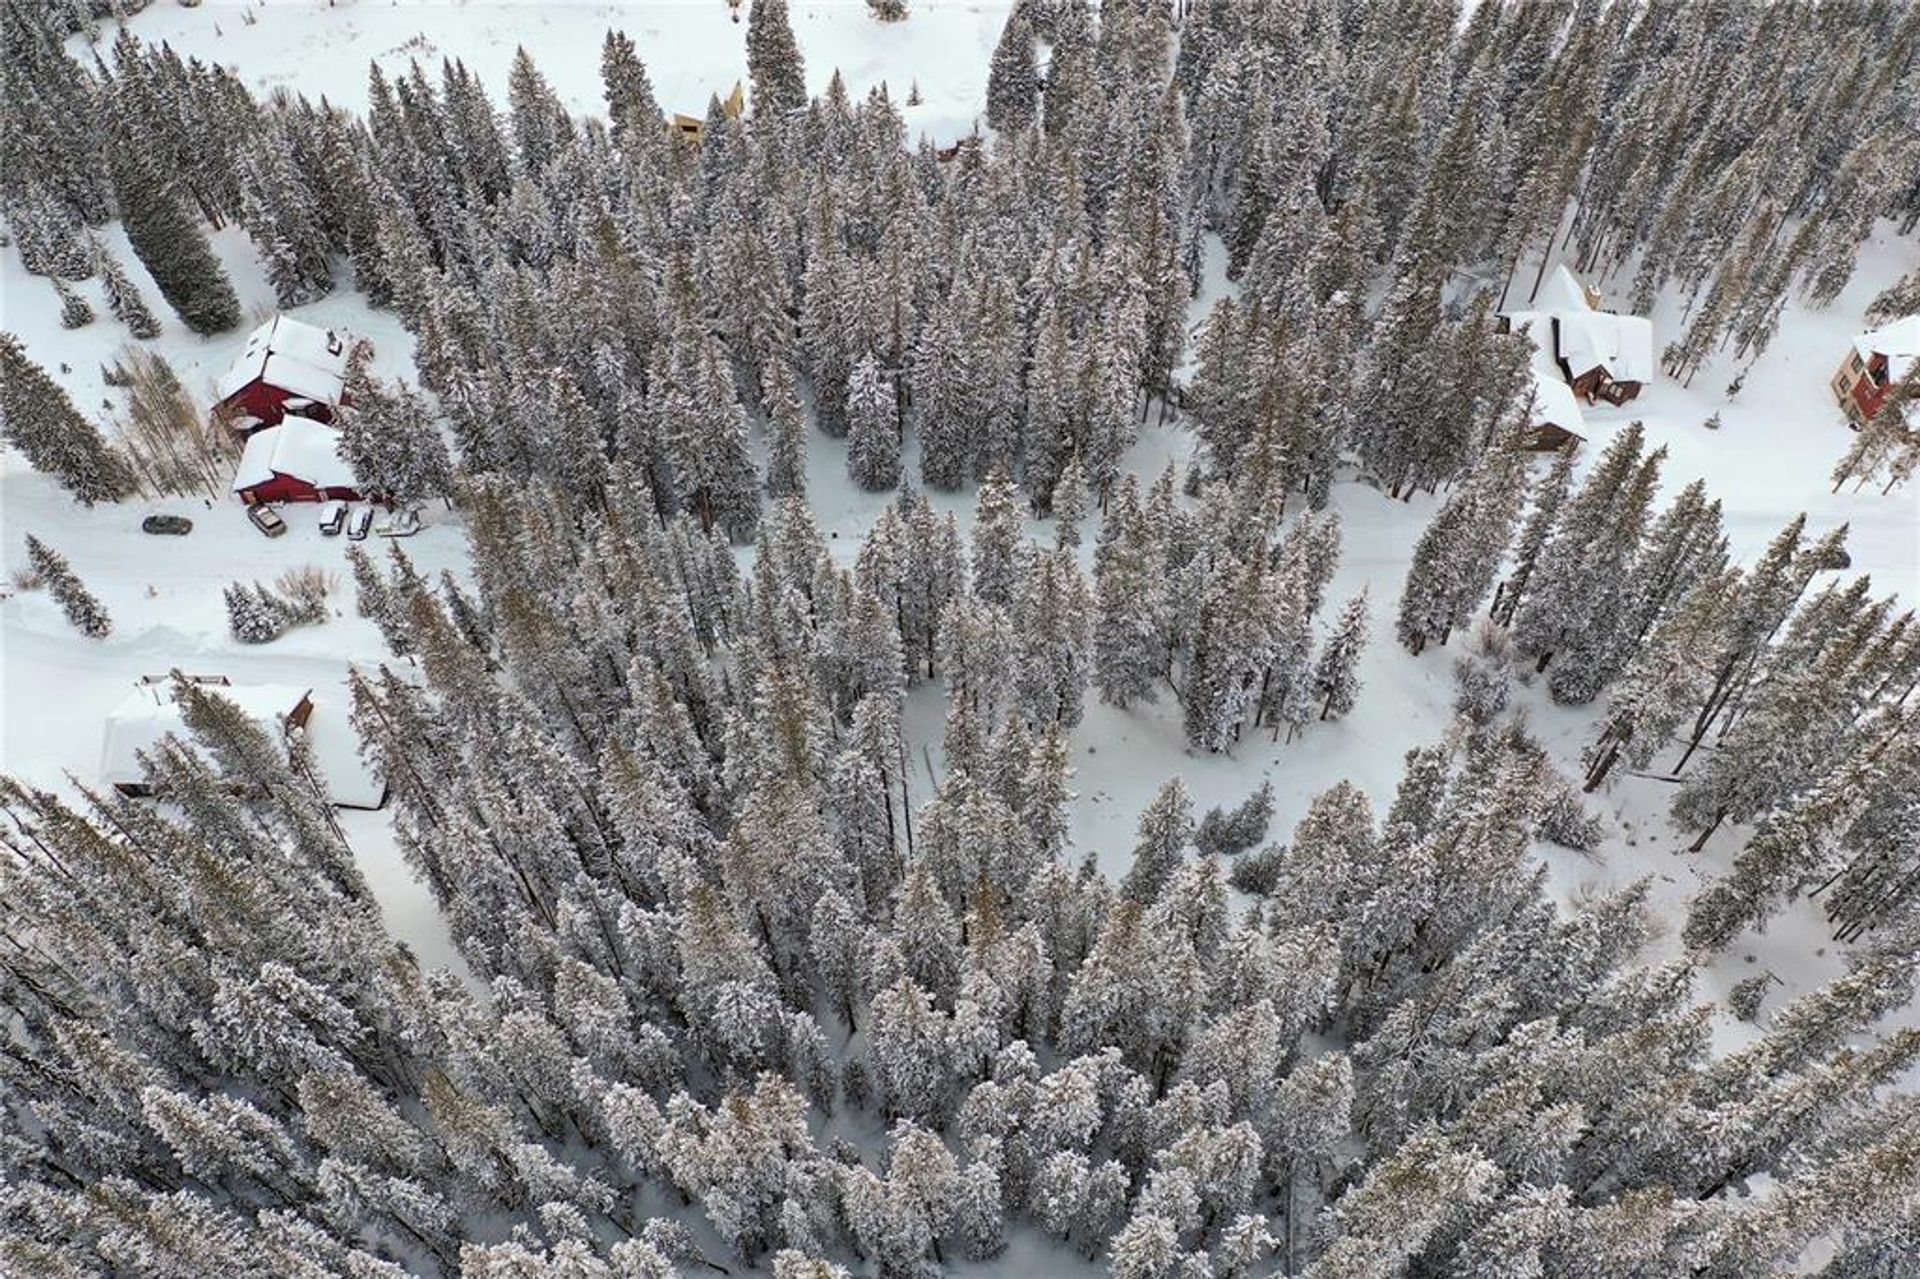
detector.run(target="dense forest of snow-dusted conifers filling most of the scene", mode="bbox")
[0,0,1920,1279]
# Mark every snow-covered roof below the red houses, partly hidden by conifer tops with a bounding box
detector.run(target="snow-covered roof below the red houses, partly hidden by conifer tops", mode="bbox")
[100,684,386,808]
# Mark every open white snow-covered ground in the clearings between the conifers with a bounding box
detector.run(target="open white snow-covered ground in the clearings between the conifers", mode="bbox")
[0,0,1920,1075]
